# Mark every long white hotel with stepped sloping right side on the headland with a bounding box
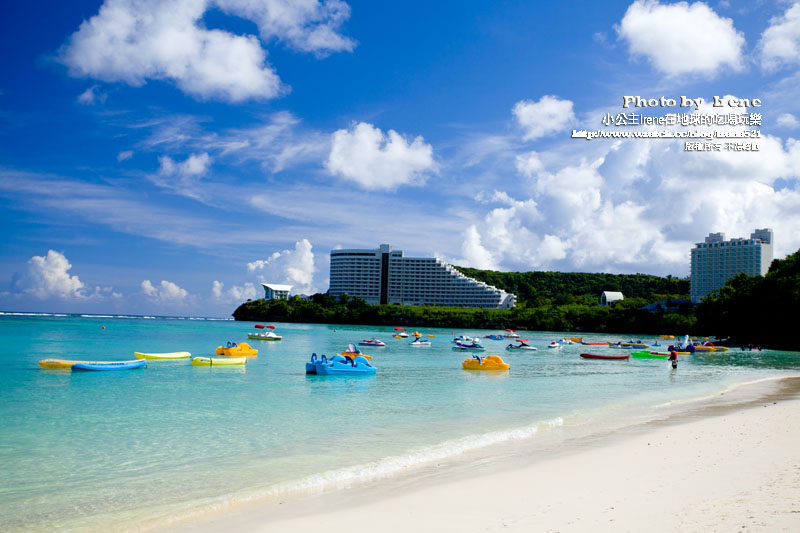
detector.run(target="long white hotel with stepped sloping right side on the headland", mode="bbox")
[328,244,515,309]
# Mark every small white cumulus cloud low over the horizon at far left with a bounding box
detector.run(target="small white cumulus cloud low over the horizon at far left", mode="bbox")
[11,250,115,301]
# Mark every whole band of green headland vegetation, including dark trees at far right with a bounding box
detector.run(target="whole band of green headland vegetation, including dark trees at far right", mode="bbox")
[233,250,800,350]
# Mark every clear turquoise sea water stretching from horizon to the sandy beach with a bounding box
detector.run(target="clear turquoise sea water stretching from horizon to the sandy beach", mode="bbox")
[0,314,800,531]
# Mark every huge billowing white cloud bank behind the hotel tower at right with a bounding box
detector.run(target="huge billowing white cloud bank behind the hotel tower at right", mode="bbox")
[462,95,800,275]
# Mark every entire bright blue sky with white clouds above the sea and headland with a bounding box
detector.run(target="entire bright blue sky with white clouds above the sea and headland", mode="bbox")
[0,0,800,316]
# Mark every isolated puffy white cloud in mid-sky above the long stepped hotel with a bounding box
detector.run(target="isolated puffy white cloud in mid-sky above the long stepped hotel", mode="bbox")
[325,122,437,189]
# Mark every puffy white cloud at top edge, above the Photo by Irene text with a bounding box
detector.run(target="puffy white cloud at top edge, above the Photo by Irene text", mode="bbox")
[616,0,745,76]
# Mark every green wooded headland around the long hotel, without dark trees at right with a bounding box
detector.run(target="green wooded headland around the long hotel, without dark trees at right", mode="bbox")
[233,269,694,333]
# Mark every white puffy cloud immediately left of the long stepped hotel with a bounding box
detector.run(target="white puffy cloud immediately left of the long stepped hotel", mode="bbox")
[247,239,316,294]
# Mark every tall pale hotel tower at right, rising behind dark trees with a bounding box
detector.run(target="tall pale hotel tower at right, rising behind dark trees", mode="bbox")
[691,228,773,303]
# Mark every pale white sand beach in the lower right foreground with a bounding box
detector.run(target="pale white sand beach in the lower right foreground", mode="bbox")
[169,377,800,532]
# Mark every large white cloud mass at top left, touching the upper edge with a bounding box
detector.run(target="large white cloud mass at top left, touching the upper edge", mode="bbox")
[59,0,354,102]
